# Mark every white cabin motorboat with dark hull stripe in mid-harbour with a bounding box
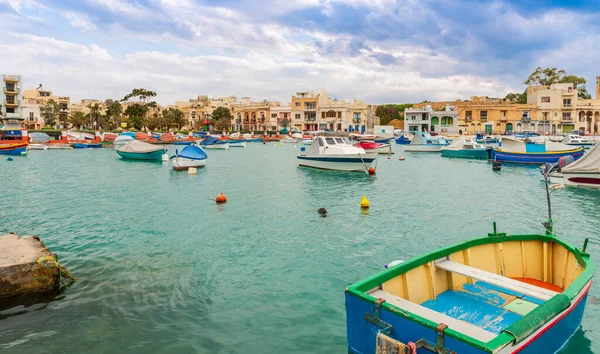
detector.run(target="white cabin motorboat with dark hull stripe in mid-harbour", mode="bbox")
[297,136,377,172]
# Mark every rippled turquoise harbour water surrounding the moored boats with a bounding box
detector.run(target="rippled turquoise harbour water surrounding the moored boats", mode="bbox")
[0,143,600,353]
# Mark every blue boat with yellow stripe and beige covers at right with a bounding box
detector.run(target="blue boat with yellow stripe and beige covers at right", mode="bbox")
[490,137,583,164]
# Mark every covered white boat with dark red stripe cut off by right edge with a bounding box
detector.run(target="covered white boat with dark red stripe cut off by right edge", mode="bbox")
[550,144,600,188]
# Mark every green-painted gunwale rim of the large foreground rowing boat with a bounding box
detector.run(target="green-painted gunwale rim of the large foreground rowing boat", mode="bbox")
[346,234,596,353]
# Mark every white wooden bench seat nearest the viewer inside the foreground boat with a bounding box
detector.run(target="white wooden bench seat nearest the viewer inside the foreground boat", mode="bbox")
[369,289,497,343]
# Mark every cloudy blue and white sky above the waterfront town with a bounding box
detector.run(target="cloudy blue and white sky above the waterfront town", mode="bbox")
[0,0,600,105]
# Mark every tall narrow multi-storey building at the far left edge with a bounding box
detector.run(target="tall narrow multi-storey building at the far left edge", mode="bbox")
[0,75,23,130]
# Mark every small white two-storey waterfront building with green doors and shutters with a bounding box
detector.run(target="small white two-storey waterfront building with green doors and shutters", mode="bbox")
[404,104,459,134]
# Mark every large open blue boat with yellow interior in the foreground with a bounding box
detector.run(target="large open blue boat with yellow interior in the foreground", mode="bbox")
[346,223,595,354]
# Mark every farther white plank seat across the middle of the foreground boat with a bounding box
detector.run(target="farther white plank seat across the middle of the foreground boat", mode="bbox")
[435,259,558,301]
